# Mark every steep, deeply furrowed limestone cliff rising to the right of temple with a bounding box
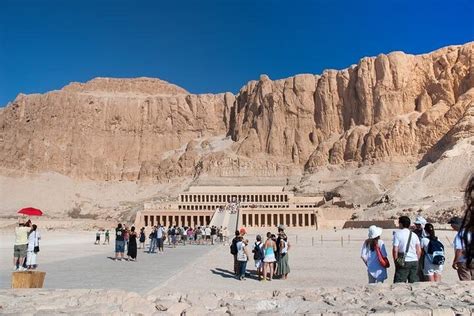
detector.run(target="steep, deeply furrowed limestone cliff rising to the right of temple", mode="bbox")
[229,43,474,171]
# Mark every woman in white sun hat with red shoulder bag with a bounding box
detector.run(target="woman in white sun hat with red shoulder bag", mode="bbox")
[360,225,388,283]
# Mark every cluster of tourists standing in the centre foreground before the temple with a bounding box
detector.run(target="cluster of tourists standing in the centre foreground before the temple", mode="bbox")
[230,225,290,281]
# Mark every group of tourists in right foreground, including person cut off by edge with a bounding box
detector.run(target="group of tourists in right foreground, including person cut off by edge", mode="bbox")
[361,177,474,283]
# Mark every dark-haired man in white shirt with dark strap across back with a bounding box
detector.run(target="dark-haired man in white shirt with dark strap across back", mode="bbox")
[392,216,421,283]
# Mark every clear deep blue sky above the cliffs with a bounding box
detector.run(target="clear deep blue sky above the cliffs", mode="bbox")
[0,0,474,106]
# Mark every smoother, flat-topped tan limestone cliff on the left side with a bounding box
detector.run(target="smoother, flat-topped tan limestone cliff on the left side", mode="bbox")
[0,78,233,180]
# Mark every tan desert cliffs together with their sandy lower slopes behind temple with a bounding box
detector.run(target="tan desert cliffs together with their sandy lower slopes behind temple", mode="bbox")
[0,42,474,223]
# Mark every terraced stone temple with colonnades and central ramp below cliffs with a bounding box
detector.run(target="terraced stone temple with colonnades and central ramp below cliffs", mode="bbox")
[135,186,352,229]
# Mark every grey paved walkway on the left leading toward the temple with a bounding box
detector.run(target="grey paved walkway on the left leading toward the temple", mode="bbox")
[0,231,214,293]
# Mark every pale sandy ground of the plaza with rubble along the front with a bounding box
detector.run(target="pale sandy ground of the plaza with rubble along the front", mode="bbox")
[0,228,474,315]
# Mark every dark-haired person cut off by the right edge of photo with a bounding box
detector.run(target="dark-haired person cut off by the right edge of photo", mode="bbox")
[453,175,474,281]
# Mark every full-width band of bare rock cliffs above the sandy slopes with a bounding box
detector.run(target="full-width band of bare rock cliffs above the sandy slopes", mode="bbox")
[0,43,474,181]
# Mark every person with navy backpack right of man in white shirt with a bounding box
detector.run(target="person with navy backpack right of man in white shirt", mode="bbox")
[420,223,445,282]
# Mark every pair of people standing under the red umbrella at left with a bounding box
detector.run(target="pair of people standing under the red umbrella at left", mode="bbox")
[13,220,41,271]
